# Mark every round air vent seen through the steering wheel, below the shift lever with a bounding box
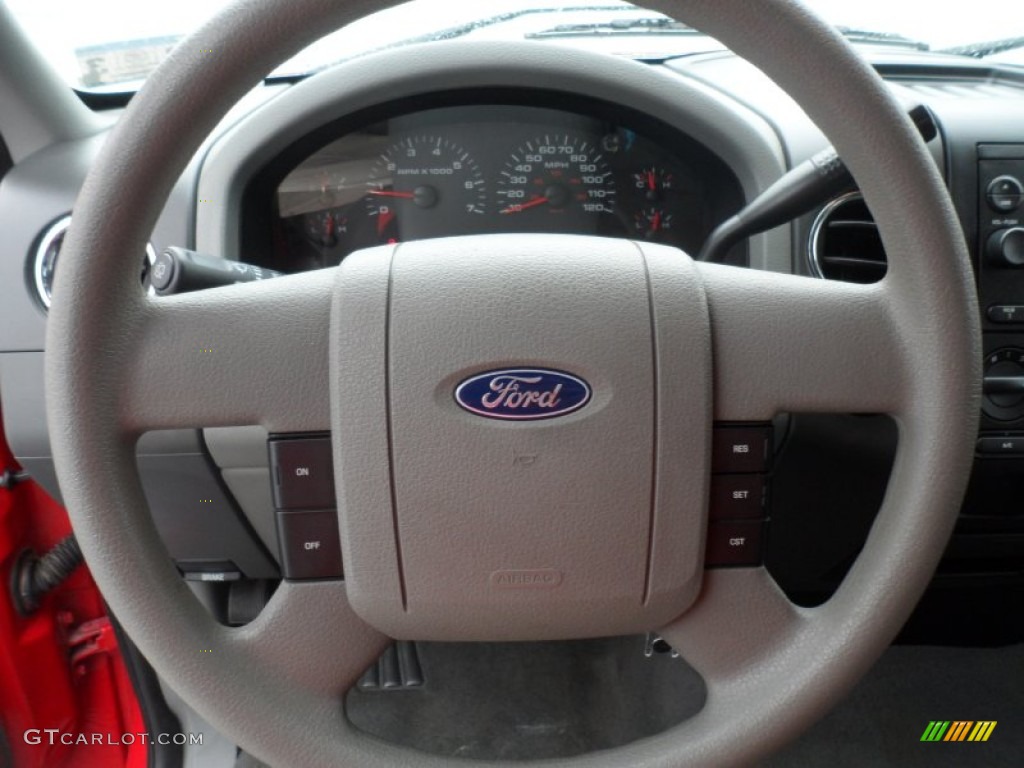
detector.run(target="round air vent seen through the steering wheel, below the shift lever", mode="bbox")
[808,193,888,283]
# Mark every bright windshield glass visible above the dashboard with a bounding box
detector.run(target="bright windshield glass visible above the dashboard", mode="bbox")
[0,0,1024,91]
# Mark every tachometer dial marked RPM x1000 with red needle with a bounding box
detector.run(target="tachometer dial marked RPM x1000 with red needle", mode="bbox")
[367,135,486,240]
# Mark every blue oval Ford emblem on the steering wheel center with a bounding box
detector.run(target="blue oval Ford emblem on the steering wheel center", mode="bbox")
[455,368,590,421]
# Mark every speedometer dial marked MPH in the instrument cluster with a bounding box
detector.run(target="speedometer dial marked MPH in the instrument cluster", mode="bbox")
[496,134,615,218]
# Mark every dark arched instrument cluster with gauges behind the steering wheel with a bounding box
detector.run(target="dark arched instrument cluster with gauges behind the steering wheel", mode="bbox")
[241,90,746,272]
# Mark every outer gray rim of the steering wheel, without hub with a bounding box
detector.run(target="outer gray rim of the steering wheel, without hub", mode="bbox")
[46,0,980,766]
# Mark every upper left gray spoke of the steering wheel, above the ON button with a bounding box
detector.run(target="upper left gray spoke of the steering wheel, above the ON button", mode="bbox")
[121,270,333,432]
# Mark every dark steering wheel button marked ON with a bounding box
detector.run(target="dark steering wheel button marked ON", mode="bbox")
[270,437,337,509]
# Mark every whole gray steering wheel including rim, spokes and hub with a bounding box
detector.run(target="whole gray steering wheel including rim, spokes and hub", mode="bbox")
[46,0,980,768]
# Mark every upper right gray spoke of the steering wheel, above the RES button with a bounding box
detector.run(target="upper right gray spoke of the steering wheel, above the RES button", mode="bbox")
[698,264,903,421]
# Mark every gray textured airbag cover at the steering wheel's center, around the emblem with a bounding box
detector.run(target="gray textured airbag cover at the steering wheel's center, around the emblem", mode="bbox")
[331,236,712,640]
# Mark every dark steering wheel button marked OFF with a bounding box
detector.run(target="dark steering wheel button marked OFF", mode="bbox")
[278,509,342,579]
